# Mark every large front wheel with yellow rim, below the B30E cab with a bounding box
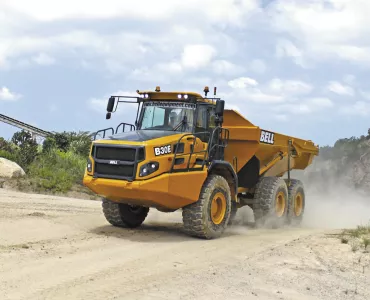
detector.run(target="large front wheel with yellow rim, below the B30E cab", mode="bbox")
[182,175,231,239]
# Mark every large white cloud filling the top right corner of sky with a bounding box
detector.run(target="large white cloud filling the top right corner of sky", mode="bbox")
[269,0,370,67]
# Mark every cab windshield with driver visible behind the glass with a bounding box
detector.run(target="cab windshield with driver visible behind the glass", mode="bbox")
[140,101,196,132]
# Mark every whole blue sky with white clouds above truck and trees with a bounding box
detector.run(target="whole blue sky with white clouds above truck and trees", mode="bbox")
[0,0,370,146]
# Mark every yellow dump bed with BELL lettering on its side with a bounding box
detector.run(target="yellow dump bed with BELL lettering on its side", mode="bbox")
[223,110,319,176]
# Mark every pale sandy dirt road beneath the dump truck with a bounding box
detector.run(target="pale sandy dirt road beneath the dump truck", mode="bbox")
[0,190,370,300]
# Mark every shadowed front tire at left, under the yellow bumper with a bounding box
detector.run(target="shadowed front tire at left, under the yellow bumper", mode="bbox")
[102,198,149,228]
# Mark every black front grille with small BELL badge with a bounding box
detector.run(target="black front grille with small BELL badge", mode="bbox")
[91,145,145,180]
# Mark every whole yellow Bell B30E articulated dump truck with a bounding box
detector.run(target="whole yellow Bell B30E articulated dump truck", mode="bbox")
[83,87,319,239]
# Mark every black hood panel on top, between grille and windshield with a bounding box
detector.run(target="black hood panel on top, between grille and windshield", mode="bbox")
[104,130,179,142]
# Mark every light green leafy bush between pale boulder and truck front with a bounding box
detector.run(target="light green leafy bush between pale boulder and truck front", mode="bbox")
[29,149,86,193]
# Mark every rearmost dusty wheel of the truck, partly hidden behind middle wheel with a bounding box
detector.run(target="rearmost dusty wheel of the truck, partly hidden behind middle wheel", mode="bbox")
[285,179,306,226]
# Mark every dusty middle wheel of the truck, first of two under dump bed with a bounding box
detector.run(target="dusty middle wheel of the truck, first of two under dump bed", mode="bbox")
[253,177,288,228]
